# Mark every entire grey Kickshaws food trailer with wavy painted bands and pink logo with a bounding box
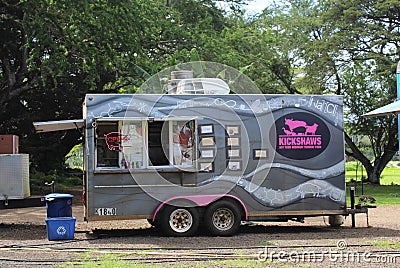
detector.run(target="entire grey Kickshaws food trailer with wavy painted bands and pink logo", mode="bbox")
[35,75,366,236]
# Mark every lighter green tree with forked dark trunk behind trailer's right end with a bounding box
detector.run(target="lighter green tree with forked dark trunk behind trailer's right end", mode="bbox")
[253,0,400,183]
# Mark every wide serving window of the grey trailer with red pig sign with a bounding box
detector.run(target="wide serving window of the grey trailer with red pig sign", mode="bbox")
[95,118,196,169]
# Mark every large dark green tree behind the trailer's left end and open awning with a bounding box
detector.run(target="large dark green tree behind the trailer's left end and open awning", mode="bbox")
[0,0,238,170]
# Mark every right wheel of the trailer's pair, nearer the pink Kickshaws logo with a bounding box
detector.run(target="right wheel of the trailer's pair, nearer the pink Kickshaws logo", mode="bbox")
[204,200,241,236]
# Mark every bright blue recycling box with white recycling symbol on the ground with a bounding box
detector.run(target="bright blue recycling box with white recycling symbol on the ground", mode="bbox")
[46,217,76,240]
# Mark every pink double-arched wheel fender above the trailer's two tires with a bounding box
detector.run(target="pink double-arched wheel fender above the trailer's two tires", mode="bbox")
[153,194,248,222]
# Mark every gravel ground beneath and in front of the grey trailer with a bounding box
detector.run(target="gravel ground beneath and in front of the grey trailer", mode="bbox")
[0,206,400,267]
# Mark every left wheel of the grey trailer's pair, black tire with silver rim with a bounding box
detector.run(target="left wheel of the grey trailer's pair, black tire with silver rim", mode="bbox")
[158,206,200,236]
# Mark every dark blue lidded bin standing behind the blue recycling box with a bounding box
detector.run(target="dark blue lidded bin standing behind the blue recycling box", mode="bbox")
[45,193,74,218]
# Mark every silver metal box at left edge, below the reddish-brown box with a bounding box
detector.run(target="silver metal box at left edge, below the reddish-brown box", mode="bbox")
[0,154,30,200]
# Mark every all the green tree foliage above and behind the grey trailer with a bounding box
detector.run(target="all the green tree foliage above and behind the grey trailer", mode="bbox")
[0,0,400,176]
